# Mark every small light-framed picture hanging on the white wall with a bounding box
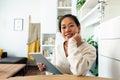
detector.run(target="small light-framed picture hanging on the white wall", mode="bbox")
[14,18,23,31]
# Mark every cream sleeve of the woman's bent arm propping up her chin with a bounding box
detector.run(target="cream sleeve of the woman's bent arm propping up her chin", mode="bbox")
[67,38,96,75]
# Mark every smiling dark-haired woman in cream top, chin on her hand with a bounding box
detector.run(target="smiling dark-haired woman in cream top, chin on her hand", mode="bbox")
[37,14,96,75]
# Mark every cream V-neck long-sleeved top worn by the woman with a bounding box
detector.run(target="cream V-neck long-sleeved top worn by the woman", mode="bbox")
[51,38,96,75]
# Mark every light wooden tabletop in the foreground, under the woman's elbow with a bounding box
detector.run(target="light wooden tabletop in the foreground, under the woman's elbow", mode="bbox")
[0,75,113,80]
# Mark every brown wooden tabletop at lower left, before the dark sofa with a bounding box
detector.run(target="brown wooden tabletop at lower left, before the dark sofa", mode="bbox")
[0,64,26,79]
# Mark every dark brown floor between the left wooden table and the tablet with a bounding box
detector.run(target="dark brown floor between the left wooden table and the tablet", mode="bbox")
[24,66,44,76]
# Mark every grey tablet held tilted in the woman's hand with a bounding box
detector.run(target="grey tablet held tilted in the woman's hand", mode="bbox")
[30,53,62,74]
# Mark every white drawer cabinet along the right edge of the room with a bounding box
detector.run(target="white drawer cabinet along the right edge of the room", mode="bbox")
[98,16,120,80]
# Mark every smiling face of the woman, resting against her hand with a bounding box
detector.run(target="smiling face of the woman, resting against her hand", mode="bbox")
[61,17,80,40]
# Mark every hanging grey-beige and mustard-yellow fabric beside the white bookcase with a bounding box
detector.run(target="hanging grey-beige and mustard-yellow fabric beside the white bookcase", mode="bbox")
[28,23,40,60]
